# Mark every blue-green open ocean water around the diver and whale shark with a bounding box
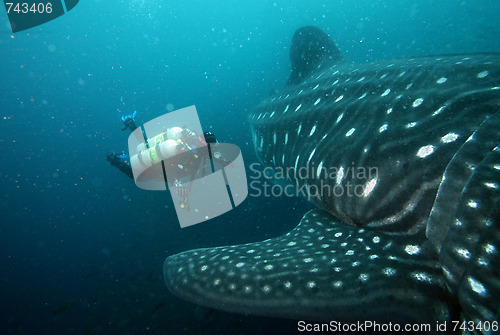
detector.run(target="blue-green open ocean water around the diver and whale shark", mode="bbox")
[0,0,500,334]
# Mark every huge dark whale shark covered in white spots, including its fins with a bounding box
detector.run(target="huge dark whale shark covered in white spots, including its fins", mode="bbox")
[163,27,500,330]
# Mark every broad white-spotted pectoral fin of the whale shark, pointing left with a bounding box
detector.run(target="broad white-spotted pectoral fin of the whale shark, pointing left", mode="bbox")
[163,209,453,322]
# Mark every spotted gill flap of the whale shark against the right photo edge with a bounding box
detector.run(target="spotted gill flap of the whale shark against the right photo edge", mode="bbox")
[440,146,500,322]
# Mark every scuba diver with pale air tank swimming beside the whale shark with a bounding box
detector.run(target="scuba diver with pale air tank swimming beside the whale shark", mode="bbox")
[106,111,229,209]
